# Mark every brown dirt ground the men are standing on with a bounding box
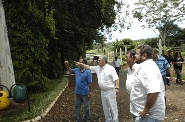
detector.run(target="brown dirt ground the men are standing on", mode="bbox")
[42,66,185,122]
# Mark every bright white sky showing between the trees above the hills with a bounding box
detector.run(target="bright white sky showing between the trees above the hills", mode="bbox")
[107,0,185,42]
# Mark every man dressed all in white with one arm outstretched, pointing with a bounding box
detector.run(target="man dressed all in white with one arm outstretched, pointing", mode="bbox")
[76,56,119,122]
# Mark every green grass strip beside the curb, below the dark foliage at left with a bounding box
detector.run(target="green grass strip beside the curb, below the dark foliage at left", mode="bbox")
[0,77,68,122]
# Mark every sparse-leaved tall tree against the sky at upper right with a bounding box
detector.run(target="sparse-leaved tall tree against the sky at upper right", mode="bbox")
[133,0,185,45]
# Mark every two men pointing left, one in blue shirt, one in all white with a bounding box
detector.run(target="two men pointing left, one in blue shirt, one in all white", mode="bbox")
[64,56,119,122]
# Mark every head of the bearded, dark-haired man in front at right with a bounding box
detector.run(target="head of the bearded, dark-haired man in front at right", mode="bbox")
[135,45,152,64]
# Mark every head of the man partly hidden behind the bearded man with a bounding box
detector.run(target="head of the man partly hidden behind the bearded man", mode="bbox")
[126,50,136,67]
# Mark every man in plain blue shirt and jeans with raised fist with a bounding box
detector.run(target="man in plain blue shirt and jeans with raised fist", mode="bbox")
[64,58,92,122]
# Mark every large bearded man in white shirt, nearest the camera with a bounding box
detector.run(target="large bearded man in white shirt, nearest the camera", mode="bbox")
[130,45,165,122]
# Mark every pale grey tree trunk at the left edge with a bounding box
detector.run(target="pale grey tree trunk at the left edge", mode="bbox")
[0,0,15,90]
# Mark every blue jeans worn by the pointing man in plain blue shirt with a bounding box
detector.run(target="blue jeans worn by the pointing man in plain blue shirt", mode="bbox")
[75,94,91,122]
